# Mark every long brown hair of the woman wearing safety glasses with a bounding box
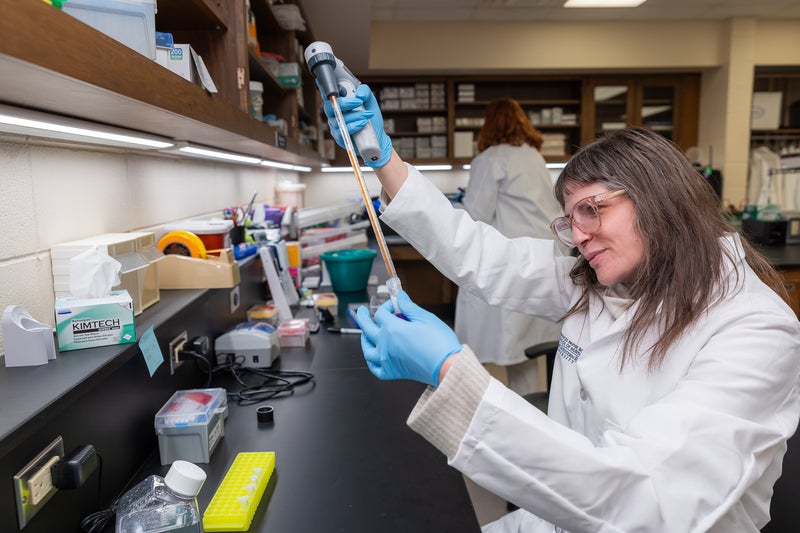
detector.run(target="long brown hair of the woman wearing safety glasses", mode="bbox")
[555,128,787,371]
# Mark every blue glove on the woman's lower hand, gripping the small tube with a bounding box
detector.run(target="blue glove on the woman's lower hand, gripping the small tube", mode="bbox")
[356,291,461,387]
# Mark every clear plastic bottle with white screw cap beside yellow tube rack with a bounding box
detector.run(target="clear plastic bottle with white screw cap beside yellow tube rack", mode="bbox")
[115,461,206,533]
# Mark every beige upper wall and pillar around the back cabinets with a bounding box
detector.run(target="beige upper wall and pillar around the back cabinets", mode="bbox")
[369,18,800,204]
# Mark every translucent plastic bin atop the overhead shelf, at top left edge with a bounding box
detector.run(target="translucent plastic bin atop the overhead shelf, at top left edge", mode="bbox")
[61,0,156,60]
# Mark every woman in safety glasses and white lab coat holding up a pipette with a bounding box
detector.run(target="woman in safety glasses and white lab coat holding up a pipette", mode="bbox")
[320,87,800,533]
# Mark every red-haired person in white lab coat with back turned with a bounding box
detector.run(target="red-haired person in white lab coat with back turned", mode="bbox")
[455,98,561,395]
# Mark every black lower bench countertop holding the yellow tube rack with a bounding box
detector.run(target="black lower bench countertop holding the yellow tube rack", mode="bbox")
[141,318,480,533]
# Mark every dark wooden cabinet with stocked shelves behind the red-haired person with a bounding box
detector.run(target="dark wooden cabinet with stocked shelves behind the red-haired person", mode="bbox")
[363,74,700,164]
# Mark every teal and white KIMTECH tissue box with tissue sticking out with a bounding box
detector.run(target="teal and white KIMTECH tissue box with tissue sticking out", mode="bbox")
[55,289,136,352]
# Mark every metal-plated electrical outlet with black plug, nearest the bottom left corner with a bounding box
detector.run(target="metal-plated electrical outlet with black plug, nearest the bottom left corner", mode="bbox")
[14,436,64,529]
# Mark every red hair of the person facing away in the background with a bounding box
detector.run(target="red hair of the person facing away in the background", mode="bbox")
[478,98,542,152]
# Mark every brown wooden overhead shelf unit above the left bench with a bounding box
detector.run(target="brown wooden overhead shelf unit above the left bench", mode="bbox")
[0,0,321,165]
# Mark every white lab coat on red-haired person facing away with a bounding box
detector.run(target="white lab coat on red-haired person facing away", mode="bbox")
[455,144,562,365]
